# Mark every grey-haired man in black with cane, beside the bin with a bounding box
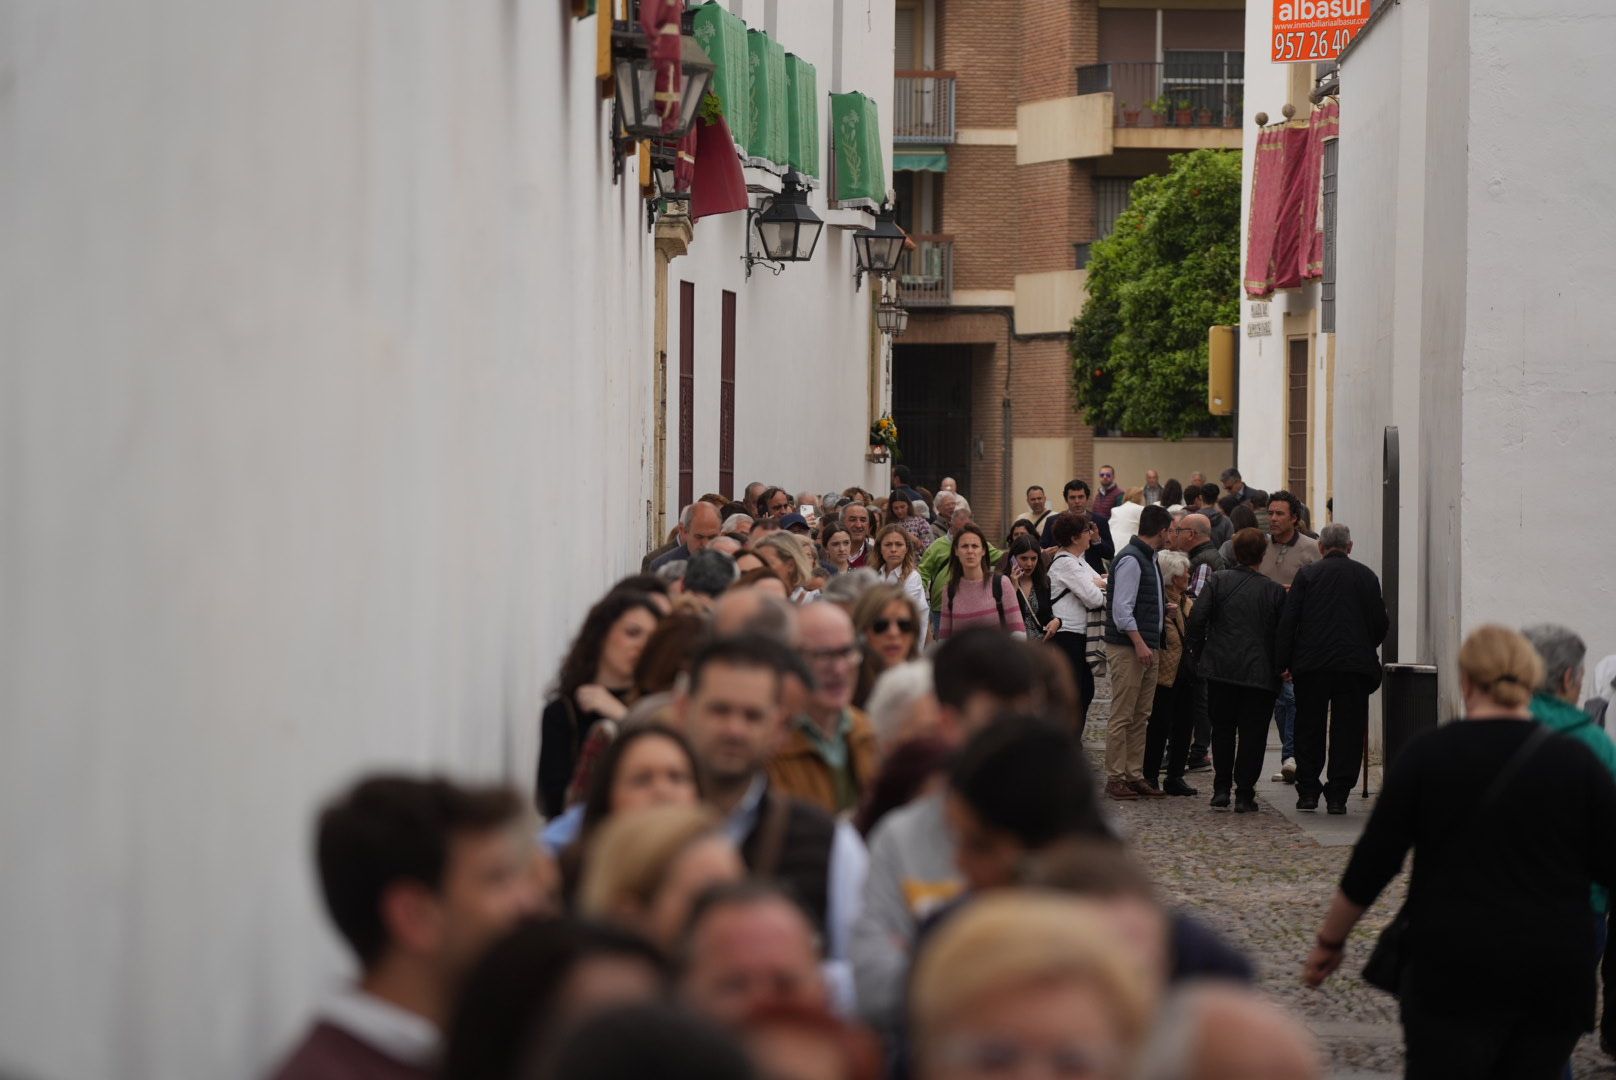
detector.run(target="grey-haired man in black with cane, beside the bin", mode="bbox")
[1278,524,1387,813]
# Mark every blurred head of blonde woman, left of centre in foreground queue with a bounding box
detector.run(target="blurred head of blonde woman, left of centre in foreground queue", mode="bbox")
[579,805,747,954]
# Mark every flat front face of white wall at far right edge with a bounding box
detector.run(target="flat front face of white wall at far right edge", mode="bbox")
[1460,0,1616,691]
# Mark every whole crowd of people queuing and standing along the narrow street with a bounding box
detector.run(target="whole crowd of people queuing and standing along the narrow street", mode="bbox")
[265,466,1616,1080]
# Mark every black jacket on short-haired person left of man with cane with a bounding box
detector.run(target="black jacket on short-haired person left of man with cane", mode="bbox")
[1185,566,1285,692]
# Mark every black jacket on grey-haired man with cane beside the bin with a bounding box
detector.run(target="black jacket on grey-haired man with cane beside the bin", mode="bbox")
[1277,551,1387,686]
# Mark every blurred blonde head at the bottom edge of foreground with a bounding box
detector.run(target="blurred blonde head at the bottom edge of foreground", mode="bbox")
[910,891,1155,1080]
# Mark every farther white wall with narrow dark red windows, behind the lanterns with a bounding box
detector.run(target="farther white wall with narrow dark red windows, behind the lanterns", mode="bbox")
[667,0,894,514]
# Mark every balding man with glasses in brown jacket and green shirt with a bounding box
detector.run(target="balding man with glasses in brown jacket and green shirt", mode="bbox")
[769,601,879,815]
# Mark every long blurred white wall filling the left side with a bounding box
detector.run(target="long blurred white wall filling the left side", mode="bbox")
[0,0,662,1080]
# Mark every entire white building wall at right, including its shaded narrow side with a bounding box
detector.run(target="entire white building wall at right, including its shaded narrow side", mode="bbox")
[1336,0,1616,708]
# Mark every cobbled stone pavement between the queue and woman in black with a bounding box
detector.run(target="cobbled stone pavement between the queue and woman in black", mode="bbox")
[1084,679,1616,1080]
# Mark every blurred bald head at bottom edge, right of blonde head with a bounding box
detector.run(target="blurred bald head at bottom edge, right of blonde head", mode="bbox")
[1136,983,1324,1080]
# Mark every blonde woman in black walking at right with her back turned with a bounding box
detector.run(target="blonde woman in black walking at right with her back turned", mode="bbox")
[1302,626,1616,1080]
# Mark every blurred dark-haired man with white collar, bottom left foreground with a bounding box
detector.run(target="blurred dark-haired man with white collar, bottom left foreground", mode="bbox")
[271,776,541,1080]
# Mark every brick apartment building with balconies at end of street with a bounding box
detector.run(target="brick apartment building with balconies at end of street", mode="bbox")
[892,0,1244,535]
